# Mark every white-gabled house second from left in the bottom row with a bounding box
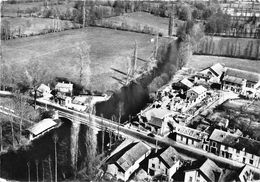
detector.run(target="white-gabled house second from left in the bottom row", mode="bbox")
[148,146,181,181]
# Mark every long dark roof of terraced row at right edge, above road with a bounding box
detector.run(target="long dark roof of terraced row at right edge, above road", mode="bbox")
[209,129,260,156]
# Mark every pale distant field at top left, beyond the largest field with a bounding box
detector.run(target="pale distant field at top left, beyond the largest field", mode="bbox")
[2,17,77,35]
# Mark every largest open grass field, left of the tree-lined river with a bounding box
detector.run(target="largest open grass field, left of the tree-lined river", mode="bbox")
[2,27,158,90]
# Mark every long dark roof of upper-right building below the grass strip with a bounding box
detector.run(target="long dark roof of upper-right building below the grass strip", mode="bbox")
[225,68,259,82]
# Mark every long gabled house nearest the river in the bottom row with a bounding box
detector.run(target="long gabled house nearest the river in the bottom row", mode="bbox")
[106,140,151,181]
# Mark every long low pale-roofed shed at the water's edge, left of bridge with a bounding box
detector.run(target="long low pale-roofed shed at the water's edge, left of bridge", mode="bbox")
[27,118,59,140]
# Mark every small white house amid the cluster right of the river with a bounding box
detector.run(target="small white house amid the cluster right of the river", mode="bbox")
[186,85,207,104]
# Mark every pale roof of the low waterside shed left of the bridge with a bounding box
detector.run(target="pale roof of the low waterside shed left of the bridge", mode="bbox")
[27,118,57,135]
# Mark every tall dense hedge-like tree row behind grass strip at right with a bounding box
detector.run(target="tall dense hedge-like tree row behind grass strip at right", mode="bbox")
[194,36,260,60]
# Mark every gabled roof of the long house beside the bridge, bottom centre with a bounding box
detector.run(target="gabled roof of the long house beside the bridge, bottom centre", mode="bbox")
[107,142,150,172]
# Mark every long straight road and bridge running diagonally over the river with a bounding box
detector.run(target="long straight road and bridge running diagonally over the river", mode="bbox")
[34,101,260,173]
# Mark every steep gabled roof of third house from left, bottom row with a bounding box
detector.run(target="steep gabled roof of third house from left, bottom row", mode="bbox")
[184,159,222,182]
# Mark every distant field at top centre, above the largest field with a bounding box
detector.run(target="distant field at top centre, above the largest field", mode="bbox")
[102,12,181,35]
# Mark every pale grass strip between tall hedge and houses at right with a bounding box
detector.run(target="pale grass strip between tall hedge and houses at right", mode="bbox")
[187,55,260,73]
